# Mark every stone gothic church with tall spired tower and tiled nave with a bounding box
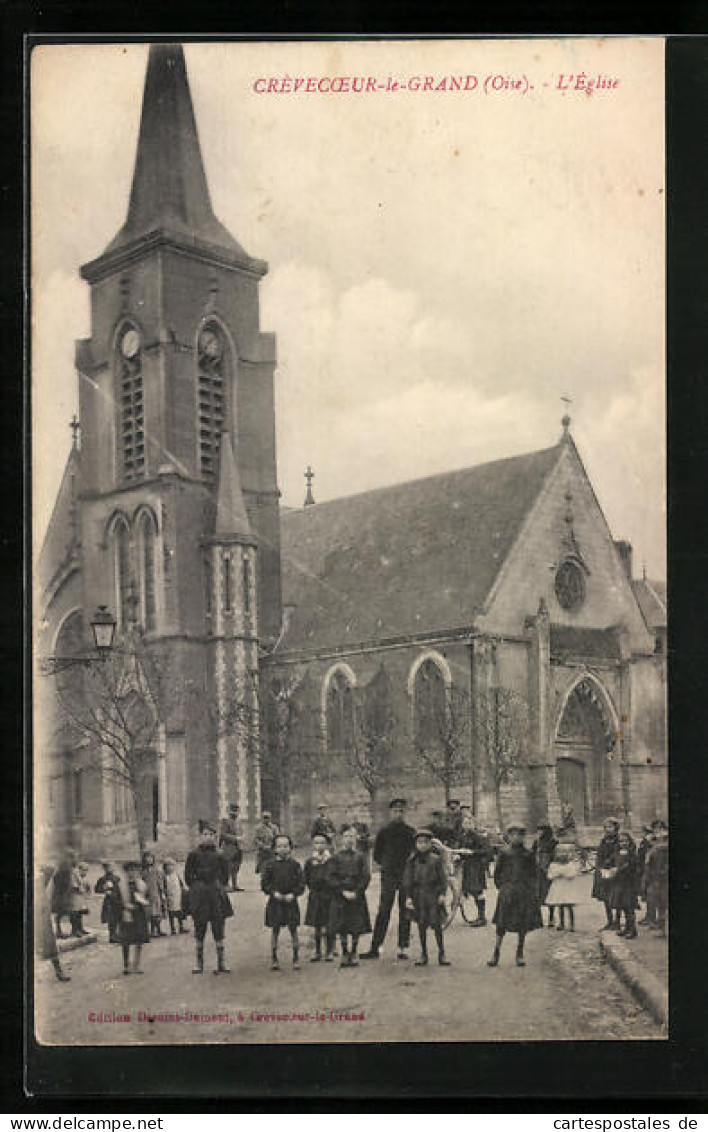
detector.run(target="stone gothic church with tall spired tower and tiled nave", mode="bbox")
[35,44,666,856]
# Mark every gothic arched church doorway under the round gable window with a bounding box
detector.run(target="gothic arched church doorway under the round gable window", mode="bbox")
[554,678,621,825]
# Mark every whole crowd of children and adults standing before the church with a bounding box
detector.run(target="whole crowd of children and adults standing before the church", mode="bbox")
[39,798,668,981]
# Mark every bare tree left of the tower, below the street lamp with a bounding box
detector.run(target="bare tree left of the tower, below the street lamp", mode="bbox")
[54,633,160,851]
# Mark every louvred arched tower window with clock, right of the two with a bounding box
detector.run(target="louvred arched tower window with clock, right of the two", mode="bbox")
[197,321,230,482]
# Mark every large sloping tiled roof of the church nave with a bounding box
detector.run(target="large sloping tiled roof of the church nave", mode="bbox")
[279,447,560,651]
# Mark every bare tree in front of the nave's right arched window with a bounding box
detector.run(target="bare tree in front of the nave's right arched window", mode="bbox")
[412,679,471,804]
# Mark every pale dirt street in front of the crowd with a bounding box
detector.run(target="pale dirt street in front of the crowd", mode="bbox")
[36,861,663,1045]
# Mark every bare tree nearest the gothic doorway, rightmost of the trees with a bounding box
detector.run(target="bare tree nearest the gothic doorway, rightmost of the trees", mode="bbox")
[472,687,529,829]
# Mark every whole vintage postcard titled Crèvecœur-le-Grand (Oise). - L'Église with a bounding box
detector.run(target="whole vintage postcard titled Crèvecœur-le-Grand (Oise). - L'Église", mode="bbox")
[31,37,668,1046]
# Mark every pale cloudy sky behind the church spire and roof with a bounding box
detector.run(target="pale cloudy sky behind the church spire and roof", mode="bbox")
[32,40,665,577]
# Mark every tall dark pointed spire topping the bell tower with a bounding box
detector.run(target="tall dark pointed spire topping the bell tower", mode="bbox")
[104,43,248,259]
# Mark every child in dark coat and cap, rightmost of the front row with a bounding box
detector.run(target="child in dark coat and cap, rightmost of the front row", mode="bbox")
[487,822,543,967]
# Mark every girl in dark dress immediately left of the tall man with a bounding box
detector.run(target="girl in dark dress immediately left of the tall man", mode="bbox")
[329,825,372,967]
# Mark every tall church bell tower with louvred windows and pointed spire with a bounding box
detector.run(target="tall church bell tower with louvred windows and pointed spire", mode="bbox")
[76,44,281,842]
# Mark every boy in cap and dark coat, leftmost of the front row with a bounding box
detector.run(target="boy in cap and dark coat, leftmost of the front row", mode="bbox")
[185,821,233,975]
